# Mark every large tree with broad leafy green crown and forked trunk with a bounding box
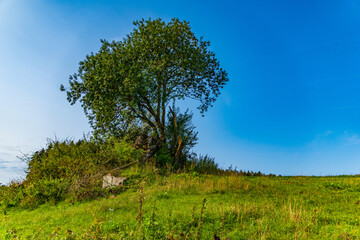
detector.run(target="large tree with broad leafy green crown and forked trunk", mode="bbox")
[61,19,228,146]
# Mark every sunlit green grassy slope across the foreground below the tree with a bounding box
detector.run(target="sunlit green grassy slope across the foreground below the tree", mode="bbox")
[0,174,360,239]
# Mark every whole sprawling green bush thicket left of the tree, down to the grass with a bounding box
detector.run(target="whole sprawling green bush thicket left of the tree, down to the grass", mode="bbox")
[0,138,142,207]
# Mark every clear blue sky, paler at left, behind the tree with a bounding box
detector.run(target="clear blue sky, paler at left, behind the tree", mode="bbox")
[0,0,360,183]
